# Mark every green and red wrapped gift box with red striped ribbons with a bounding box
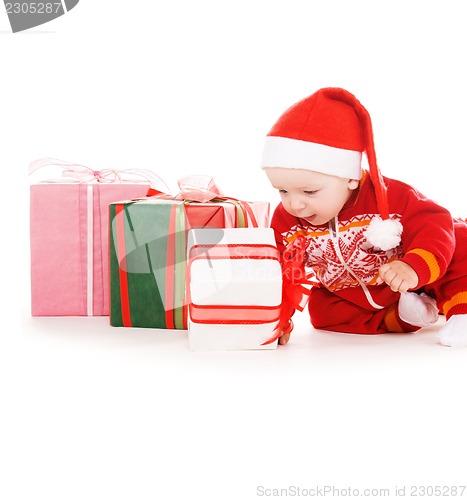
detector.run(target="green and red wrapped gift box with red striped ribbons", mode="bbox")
[110,190,269,329]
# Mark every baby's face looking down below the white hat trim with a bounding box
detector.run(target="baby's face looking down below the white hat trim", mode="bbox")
[264,167,358,226]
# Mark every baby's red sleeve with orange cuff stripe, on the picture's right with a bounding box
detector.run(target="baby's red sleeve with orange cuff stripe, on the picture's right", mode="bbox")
[388,180,455,287]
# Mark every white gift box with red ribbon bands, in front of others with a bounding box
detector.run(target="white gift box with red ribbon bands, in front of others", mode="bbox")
[187,228,282,350]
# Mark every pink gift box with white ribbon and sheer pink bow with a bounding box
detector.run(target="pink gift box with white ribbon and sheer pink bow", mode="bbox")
[30,160,162,316]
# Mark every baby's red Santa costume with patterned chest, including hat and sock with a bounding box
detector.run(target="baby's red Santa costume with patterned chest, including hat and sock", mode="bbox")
[262,88,467,346]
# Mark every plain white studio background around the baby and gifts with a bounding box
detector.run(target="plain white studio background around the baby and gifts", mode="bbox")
[0,0,467,500]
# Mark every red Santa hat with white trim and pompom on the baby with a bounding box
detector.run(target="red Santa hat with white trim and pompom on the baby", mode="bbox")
[262,88,402,250]
